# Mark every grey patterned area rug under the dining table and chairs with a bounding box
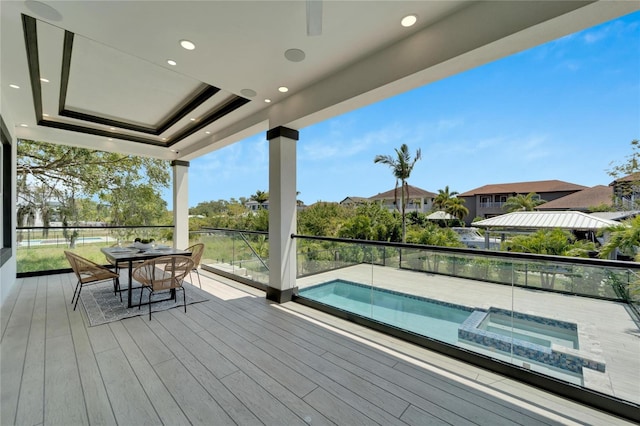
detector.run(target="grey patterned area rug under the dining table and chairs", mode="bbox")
[80,281,209,327]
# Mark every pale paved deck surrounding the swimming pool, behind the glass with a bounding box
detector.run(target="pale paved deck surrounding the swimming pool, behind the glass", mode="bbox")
[297,265,640,403]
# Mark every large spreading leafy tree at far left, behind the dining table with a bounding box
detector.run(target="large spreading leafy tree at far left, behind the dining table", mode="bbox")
[17,140,170,225]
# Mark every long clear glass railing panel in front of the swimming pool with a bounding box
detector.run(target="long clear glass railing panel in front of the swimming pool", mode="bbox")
[298,236,640,404]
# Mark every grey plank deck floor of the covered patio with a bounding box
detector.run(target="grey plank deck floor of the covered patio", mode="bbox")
[0,272,628,426]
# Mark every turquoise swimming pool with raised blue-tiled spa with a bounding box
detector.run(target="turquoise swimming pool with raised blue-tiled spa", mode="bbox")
[299,280,605,374]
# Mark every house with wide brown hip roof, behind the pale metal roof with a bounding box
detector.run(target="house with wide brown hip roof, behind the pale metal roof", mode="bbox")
[458,180,586,225]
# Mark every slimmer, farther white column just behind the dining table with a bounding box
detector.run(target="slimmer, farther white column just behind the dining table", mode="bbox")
[171,160,189,249]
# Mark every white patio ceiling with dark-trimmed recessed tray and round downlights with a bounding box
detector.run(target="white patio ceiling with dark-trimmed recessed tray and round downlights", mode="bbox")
[0,0,640,160]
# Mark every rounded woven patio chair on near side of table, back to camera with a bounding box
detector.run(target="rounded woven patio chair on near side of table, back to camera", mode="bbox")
[132,256,193,321]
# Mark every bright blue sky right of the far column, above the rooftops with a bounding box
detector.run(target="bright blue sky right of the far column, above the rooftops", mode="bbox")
[172,12,640,207]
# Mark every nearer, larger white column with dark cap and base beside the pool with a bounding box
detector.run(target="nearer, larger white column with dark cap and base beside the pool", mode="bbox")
[267,127,298,303]
